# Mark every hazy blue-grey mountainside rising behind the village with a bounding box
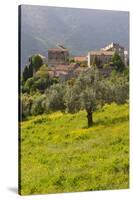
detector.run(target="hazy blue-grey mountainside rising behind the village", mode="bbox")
[21,5,129,67]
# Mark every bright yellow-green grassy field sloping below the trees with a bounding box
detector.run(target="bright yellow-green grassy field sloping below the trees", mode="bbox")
[20,104,129,195]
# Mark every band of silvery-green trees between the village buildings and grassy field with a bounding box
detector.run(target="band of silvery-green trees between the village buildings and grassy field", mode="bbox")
[22,66,129,126]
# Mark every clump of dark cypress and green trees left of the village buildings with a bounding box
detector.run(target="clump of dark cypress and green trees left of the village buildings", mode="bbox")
[21,54,59,95]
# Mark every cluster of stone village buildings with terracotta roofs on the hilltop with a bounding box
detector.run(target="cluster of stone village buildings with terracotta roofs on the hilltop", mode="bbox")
[34,42,129,79]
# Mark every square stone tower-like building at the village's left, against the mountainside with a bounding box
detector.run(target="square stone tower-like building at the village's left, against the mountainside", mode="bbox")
[48,46,69,66]
